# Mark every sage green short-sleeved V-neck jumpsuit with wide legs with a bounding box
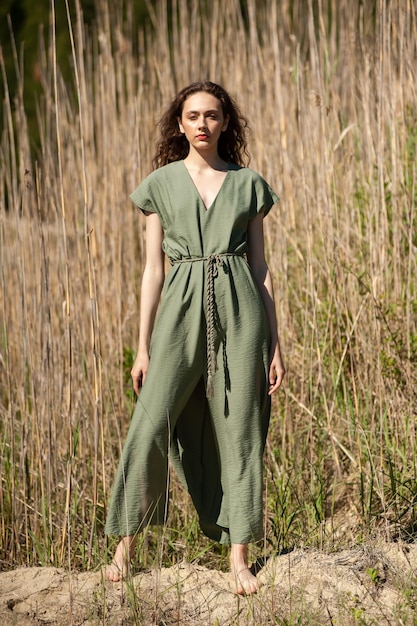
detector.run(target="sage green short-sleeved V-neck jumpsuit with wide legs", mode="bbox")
[106,161,278,543]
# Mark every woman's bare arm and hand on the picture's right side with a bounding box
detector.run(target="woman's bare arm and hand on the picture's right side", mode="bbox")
[248,214,285,395]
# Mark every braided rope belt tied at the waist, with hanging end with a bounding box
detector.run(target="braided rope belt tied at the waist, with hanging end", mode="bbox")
[170,252,243,398]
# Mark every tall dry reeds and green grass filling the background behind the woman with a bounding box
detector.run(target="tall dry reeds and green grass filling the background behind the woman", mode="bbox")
[0,0,417,596]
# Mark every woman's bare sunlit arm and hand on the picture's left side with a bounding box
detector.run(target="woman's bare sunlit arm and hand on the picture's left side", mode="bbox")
[131,213,165,395]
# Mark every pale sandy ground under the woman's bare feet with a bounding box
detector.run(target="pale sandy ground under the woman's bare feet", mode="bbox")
[0,543,417,626]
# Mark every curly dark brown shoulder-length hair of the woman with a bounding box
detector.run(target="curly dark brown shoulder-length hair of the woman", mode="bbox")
[152,81,250,169]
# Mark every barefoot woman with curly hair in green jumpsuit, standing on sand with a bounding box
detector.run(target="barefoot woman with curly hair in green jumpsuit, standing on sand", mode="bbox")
[105,82,285,594]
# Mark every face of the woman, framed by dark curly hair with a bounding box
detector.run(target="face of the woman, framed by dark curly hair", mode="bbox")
[178,91,229,150]
